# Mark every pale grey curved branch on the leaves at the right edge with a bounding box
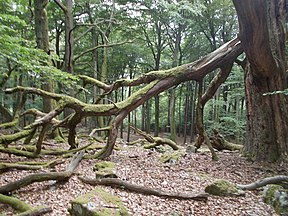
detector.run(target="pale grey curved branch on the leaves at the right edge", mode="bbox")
[237,175,288,190]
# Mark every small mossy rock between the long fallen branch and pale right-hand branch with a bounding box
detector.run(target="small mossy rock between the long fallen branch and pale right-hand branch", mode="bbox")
[205,179,243,196]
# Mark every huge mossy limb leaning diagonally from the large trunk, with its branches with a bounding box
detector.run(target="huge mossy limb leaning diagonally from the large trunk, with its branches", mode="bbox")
[0,39,242,158]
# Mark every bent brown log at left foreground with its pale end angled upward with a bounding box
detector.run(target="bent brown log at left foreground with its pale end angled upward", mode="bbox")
[0,151,84,194]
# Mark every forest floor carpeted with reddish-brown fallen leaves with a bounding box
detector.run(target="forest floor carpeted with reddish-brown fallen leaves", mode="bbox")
[0,132,288,216]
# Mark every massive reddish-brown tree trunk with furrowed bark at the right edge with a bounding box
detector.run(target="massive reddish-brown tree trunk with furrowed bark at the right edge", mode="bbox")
[233,0,288,161]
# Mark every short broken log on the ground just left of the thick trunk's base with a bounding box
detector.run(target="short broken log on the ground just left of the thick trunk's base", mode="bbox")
[210,129,243,151]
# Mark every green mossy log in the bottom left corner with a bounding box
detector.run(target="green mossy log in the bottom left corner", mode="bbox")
[0,194,52,216]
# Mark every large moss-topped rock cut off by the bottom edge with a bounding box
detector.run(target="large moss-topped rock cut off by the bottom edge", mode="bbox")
[69,187,128,216]
